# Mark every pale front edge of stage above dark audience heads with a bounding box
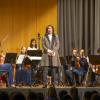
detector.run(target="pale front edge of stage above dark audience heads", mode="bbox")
[0,86,100,100]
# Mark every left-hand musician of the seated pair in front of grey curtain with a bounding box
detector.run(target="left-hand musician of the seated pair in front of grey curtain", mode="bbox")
[64,48,77,85]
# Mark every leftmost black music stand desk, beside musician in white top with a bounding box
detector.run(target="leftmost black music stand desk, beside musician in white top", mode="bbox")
[4,53,17,64]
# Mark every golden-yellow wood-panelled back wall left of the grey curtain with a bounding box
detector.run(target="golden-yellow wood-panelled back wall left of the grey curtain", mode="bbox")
[0,0,57,52]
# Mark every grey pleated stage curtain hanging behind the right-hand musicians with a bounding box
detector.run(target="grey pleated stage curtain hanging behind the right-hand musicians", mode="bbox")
[58,0,100,56]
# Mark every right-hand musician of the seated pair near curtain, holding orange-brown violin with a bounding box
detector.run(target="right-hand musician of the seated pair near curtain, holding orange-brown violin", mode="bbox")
[73,49,89,84]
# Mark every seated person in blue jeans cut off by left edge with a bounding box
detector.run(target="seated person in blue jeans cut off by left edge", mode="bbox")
[0,53,15,87]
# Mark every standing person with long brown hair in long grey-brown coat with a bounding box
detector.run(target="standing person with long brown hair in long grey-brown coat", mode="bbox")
[42,25,60,88]
